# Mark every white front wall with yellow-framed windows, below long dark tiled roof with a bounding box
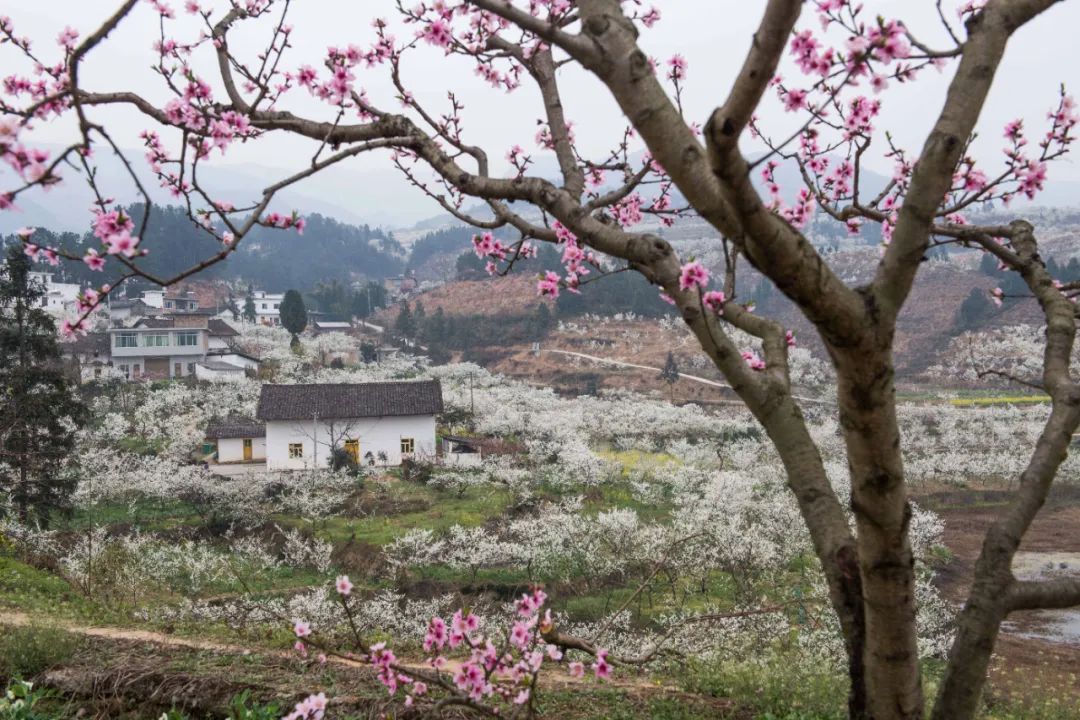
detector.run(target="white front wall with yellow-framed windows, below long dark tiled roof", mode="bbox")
[266,415,435,470]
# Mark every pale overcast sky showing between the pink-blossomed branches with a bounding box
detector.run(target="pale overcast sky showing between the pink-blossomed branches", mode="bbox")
[0,0,1080,226]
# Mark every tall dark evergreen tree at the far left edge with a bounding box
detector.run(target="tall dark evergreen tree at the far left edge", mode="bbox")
[0,245,86,525]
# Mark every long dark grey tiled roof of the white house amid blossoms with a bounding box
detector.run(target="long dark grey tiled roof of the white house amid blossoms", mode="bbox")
[256,380,443,421]
